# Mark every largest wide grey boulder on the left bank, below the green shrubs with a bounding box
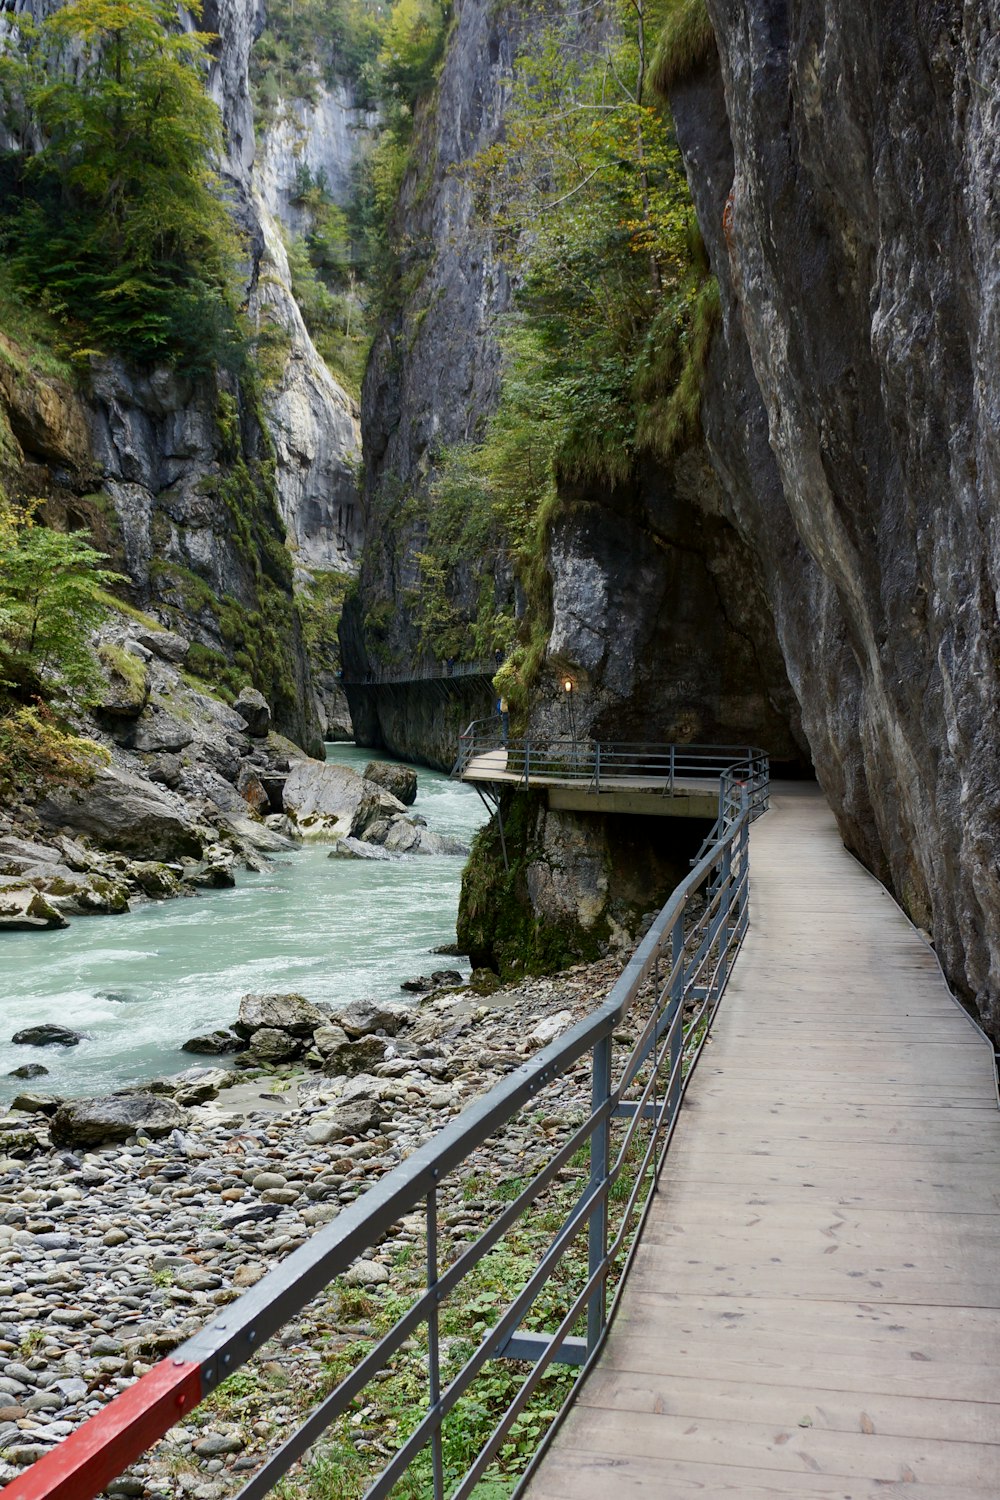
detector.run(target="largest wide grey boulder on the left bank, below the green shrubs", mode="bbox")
[37,767,204,860]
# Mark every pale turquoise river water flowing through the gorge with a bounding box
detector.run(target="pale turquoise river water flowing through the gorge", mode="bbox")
[0,746,486,1101]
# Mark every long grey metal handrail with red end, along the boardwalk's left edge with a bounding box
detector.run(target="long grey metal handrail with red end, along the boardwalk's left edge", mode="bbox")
[4,768,761,1500]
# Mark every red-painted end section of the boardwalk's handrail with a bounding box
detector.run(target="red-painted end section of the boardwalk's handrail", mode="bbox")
[0,1359,202,1500]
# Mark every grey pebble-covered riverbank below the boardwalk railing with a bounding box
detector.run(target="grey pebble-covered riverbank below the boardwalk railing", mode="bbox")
[0,959,641,1500]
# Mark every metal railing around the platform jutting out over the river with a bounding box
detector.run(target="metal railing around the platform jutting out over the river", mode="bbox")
[451,717,769,822]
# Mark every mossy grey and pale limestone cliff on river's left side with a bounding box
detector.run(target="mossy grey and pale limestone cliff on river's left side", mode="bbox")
[0,0,367,747]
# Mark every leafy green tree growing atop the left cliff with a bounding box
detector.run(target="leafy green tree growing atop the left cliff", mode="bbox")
[0,0,238,368]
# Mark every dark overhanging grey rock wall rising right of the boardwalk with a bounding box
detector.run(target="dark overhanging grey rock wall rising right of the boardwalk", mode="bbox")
[672,0,1000,1035]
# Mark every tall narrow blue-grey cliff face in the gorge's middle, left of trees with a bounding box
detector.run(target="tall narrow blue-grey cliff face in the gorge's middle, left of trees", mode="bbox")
[342,0,523,738]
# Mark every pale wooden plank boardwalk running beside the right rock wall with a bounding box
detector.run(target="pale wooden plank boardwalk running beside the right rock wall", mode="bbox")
[526,786,1000,1500]
